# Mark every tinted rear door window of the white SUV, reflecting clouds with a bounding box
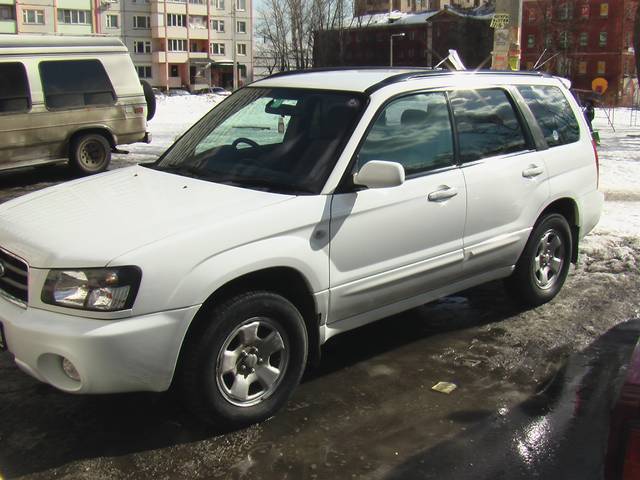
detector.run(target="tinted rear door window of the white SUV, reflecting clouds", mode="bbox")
[449,89,527,162]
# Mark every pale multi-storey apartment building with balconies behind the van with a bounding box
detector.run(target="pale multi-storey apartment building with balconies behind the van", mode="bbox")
[0,0,253,90]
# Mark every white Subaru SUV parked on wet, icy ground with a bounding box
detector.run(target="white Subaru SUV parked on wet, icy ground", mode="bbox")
[0,69,603,426]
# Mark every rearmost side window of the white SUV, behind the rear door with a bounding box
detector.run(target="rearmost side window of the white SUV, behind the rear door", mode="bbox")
[518,86,580,147]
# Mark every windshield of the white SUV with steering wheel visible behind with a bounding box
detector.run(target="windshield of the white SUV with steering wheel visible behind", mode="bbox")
[151,87,364,194]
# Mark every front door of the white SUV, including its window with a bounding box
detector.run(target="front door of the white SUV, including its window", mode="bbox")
[329,92,466,322]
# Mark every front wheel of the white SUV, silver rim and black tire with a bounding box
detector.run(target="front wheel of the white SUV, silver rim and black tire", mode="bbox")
[179,291,308,430]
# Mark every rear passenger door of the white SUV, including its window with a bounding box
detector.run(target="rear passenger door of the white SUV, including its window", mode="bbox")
[449,88,549,276]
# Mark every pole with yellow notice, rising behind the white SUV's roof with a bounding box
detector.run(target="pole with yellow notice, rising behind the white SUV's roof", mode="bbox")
[491,0,523,70]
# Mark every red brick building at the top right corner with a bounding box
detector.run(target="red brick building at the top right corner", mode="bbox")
[521,0,638,105]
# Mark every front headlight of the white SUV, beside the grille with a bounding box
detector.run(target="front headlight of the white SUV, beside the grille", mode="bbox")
[41,267,142,312]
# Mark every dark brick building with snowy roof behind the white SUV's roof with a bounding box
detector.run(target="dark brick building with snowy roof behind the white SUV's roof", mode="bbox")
[313,8,493,68]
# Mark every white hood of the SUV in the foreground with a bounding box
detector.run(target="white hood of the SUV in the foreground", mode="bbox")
[0,166,294,268]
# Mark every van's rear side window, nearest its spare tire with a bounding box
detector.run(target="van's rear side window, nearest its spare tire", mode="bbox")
[40,60,116,109]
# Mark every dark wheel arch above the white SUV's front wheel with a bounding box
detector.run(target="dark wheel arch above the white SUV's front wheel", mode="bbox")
[174,267,320,380]
